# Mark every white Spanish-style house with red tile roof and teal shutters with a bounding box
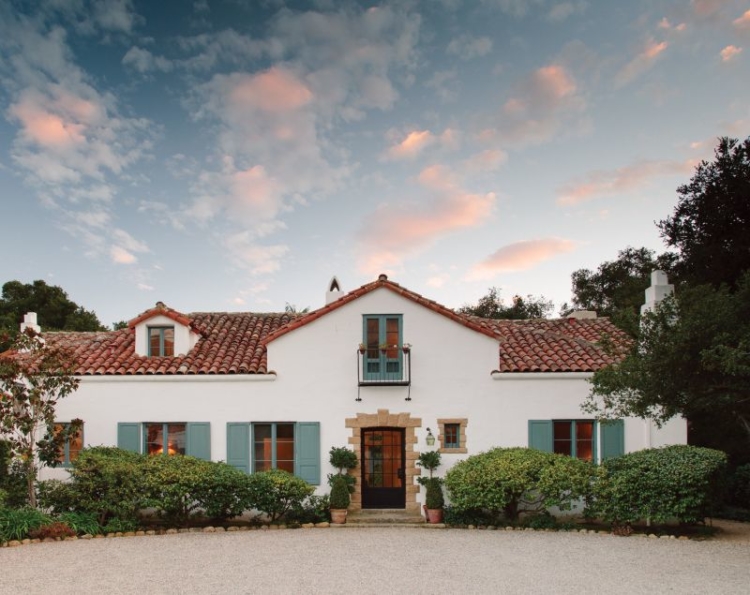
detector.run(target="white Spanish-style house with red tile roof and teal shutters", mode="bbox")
[35,275,687,513]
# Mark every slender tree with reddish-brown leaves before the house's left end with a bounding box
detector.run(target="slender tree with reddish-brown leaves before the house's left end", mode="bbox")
[0,333,82,507]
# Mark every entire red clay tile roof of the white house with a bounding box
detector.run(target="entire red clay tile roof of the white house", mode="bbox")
[38,275,630,376]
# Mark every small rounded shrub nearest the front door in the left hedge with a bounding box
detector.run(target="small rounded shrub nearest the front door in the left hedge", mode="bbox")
[248,469,316,523]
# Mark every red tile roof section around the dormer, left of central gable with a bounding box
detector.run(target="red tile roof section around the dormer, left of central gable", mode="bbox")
[44,312,294,376]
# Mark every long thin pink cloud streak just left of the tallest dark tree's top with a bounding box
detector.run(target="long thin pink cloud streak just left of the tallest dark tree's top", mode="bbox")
[557,161,695,206]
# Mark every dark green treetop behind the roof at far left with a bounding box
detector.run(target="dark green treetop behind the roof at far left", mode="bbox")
[0,280,107,334]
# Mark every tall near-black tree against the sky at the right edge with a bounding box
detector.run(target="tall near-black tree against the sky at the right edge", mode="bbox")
[658,137,750,287]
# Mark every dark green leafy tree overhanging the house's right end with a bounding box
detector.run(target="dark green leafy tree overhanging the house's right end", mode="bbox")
[584,273,750,450]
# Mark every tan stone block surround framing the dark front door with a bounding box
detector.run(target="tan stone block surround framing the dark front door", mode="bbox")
[346,409,422,514]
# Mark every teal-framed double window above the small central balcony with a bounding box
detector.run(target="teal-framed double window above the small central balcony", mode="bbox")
[363,314,404,381]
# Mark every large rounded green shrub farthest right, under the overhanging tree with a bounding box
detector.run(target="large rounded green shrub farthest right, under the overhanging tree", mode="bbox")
[590,445,727,524]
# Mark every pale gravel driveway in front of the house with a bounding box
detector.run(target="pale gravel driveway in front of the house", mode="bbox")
[0,528,750,595]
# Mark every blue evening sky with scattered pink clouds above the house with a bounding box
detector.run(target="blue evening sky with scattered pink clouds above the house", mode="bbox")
[0,0,750,325]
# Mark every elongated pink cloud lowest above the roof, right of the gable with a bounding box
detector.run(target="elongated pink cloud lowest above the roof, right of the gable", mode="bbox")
[466,238,576,281]
